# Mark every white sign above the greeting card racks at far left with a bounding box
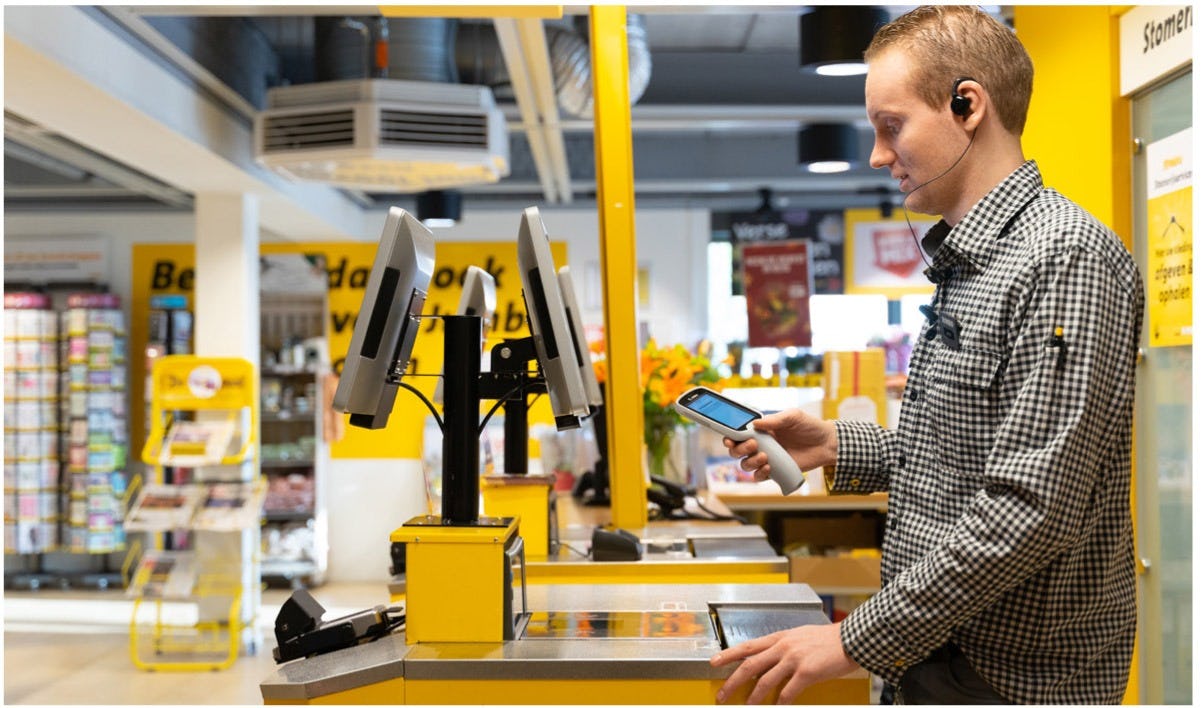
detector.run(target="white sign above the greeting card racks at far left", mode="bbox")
[4,236,108,284]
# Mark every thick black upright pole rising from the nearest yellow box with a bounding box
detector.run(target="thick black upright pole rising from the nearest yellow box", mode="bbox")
[443,315,481,525]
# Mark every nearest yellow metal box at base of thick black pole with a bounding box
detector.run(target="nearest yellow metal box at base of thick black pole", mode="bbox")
[389,515,526,644]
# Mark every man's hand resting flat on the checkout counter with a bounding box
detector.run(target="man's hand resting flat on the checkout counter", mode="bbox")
[710,623,858,706]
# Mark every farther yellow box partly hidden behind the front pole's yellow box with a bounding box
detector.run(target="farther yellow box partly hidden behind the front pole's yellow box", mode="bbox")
[480,474,557,561]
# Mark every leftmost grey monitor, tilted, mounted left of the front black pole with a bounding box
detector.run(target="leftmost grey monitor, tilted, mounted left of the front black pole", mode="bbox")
[334,207,435,430]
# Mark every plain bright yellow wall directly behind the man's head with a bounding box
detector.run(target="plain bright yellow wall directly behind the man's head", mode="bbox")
[1015,5,1133,247]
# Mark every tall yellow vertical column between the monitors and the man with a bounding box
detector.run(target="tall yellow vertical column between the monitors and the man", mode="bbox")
[590,5,648,529]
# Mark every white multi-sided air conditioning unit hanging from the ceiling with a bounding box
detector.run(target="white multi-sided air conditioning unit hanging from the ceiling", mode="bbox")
[255,78,510,191]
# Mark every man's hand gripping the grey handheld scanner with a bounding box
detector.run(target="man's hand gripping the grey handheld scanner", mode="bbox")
[724,408,837,482]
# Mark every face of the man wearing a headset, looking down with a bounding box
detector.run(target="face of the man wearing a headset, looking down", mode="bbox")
[866,48,969,216]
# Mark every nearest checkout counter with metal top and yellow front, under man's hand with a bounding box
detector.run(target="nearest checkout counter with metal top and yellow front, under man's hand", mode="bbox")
[260,584,869,704]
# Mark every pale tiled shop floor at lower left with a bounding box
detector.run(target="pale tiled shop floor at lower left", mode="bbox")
[4,584,389,706]
